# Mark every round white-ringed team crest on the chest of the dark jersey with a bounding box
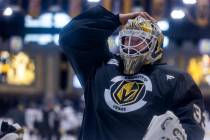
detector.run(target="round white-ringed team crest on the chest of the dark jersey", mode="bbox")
[104,74,152,113]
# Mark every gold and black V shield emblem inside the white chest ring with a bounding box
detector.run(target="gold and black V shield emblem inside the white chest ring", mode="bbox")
[112,81,144,105]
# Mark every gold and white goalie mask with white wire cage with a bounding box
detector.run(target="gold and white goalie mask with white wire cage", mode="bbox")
[119,16,163,75]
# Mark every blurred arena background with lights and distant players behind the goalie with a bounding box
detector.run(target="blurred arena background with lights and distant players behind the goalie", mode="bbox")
[0,0,210,140]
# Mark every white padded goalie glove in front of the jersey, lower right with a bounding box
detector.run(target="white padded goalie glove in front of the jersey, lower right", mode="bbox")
[143,111,187,140]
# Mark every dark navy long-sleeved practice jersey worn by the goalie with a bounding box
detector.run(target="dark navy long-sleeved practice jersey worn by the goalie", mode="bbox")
[60,6,204,140]
